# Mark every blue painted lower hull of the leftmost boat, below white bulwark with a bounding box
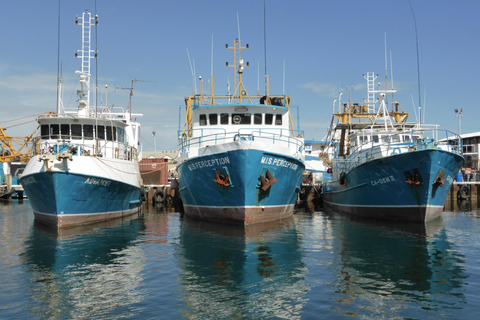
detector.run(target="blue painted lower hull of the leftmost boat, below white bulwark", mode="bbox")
[20,172,141,227]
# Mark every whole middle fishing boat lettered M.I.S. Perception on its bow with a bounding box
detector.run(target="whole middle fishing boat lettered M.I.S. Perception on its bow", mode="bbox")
[177,39,305,225]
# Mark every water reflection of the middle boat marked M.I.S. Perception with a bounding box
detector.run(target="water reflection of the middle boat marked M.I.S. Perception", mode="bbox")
[178,217,309,319]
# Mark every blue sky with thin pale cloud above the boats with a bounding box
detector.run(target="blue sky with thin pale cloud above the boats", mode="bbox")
[0,0,480,151]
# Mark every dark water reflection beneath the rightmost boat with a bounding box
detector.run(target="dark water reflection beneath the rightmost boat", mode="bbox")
[328,212,466,317]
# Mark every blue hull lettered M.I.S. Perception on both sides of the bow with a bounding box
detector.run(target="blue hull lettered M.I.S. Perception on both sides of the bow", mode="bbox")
[177,149,305,225]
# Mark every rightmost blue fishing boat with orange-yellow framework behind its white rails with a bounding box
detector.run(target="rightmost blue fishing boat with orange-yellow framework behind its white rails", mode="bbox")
[323,72,464,221]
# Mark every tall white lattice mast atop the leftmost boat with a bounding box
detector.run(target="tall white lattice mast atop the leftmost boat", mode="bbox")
[75,10,98,117]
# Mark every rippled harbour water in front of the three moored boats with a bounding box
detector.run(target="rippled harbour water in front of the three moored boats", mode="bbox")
[0,200,480,319]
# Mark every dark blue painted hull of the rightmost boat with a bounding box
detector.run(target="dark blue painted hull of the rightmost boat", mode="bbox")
[323,149,464,221]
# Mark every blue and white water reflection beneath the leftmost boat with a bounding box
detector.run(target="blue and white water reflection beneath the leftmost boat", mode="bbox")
[22,216,144,318]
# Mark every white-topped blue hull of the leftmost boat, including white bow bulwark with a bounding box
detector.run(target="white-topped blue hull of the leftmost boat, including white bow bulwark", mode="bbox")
[20,157,142,228]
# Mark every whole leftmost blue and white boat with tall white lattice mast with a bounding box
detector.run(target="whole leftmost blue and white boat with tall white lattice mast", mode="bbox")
[19,11,142,228]
